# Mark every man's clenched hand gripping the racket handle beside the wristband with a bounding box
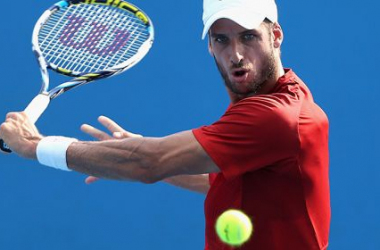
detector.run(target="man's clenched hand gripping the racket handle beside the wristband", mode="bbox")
[0,112,43,159]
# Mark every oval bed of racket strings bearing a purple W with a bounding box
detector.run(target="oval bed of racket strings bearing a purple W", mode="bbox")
[39,4,149,72]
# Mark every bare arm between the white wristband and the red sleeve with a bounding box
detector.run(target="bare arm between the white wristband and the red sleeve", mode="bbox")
[67,131,218,183]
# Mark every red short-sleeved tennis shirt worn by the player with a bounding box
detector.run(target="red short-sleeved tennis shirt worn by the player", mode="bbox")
[193,69,330,250]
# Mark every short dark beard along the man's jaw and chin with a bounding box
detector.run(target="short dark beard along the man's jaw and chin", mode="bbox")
[214,50,277,97]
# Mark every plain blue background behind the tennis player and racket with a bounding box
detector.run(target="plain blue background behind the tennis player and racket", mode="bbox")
[0,0,380,250]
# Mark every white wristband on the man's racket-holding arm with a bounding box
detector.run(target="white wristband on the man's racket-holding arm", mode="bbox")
[36,136,78,171]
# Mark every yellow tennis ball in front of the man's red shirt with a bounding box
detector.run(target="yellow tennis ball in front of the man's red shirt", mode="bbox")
[215,209,253,246]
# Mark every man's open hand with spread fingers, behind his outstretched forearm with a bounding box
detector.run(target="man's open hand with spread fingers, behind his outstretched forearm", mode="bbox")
[81,116,142,184]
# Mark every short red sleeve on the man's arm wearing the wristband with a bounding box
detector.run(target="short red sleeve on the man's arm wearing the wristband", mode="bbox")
[193,96,299,179]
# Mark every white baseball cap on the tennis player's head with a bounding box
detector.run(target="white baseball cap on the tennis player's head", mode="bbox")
[202,0,277,39]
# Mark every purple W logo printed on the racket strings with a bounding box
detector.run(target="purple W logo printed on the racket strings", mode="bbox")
[59,15,130,56]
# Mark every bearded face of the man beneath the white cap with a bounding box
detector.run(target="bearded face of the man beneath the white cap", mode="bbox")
[209,19,276,100]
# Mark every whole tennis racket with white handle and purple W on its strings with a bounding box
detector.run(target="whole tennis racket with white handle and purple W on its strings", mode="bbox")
[0,0,154,153]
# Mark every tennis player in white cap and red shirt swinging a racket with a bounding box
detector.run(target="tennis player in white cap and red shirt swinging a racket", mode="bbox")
[0,0,330,250]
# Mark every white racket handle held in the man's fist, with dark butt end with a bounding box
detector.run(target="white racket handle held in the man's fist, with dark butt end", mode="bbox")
[0,94,50,153]
